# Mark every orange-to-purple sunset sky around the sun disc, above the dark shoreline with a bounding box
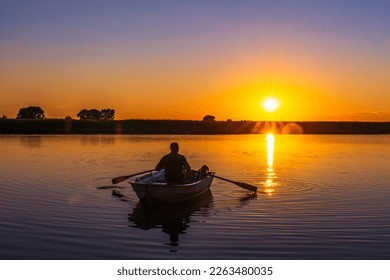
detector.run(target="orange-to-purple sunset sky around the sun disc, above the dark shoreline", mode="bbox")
[0,0,390,121]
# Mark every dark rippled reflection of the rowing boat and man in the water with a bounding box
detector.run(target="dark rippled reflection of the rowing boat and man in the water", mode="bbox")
[129,189,213,246]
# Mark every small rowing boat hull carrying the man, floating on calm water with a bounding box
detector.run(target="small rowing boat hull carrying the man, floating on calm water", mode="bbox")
[129,170,214,202]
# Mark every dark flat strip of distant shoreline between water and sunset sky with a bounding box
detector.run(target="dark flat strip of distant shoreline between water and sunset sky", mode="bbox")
[0,119,390,135]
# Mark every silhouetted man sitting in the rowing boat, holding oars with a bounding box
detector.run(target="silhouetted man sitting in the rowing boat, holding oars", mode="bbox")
[156,142,191,183]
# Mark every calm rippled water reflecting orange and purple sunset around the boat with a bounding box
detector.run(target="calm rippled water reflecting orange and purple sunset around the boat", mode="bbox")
[0,135,390,259]
